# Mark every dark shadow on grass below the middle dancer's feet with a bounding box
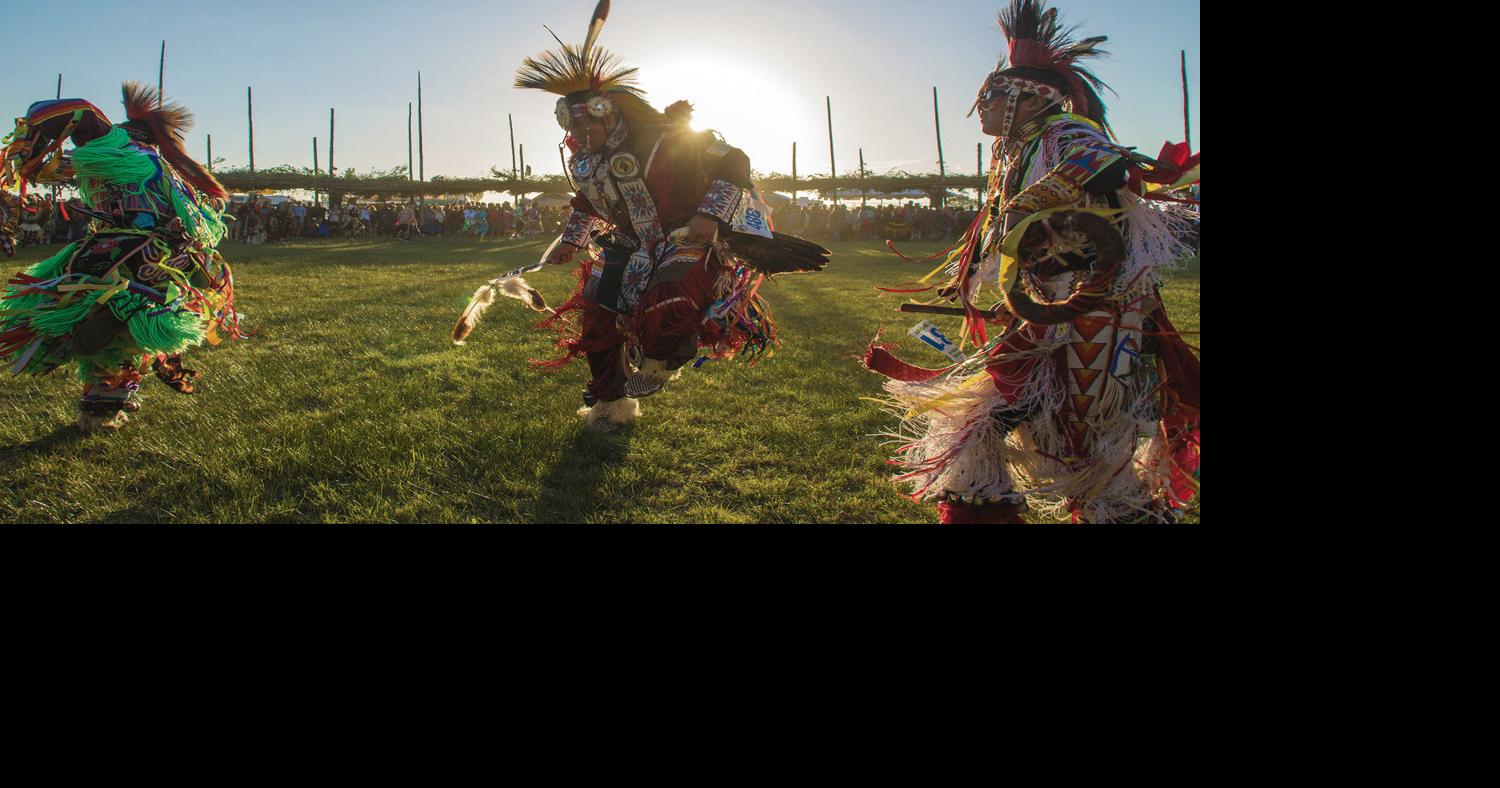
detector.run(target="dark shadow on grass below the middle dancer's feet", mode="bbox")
[531,426,635,524]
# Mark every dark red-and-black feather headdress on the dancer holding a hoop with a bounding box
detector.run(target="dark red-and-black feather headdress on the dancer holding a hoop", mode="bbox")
[980,0,1109,135]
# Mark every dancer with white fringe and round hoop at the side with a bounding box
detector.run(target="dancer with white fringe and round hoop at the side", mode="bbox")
[866,0,1199,524]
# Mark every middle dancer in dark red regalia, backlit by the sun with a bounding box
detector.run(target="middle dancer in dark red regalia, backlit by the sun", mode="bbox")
[455,0,828,431]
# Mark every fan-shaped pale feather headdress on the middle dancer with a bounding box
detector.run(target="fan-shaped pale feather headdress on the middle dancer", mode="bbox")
[516,0,662,132]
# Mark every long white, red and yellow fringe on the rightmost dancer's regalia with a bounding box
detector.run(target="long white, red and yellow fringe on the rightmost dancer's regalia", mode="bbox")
[866,118,1200,522]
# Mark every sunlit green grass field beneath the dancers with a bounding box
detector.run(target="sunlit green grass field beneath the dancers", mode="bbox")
[0,239,1199,522]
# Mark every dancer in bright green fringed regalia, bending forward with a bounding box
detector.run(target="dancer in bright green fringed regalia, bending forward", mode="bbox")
[0,83,240,431]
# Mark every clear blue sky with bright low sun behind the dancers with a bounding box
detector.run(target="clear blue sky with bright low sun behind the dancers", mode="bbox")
[0,0,1202,177]
